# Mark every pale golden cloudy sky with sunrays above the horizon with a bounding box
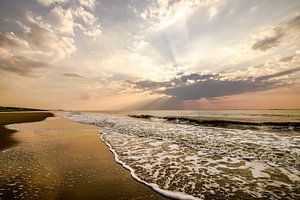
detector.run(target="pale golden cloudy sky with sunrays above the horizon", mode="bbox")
[0,0,300,110]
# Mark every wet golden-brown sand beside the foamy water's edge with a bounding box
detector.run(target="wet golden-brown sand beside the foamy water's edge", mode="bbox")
[0,113,165,199]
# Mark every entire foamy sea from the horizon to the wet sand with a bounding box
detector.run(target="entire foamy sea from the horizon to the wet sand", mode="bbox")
[64,110,300,199]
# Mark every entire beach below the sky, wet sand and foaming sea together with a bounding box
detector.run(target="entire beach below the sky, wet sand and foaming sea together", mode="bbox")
[0,111,300,200]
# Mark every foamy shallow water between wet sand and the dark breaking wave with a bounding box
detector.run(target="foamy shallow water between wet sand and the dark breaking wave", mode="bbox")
[67,113,300,199]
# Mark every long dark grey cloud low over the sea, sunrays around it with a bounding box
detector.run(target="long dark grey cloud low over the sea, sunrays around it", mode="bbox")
[134,67,300,100]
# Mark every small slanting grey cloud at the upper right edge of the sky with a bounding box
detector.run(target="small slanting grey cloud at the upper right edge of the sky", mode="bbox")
[252,14,300,51]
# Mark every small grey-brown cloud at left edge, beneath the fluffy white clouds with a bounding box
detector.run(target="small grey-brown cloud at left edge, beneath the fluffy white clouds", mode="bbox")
[0,55,49,76]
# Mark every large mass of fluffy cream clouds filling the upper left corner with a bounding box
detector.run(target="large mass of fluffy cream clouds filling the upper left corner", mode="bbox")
[0,0,102,75]
